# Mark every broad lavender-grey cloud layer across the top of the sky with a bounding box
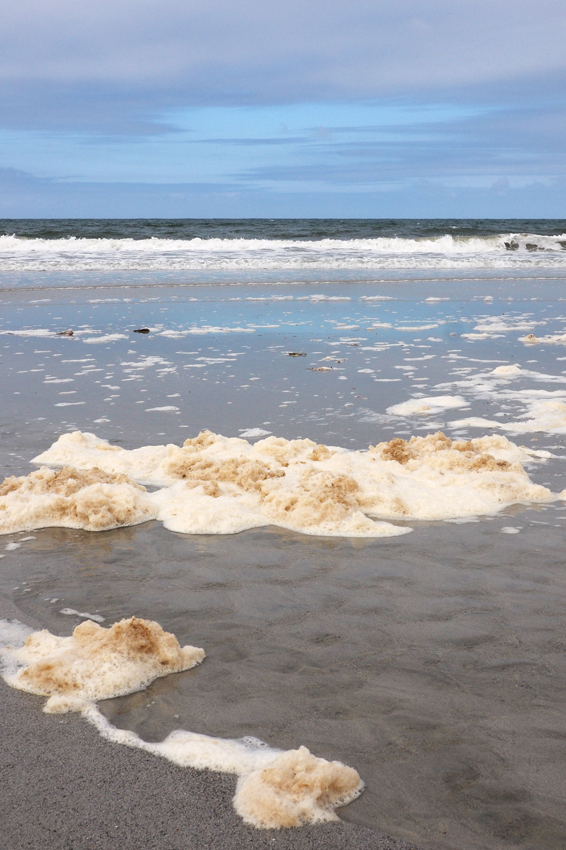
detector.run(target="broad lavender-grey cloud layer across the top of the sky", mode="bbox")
[0,0,566,133]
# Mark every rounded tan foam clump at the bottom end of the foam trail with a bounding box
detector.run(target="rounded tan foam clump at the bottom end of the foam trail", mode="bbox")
[234,747,363,829]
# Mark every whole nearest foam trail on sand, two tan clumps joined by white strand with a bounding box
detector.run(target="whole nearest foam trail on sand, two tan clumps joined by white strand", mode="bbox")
[0,617,363,828]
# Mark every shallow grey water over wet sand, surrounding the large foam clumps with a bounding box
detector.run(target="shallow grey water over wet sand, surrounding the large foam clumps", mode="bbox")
[0,273,566,850]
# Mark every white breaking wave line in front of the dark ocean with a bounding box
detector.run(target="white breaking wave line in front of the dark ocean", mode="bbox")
[0,233,566,271]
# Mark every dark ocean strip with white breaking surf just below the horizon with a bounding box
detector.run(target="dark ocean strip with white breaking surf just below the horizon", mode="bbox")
[0,219,566,271]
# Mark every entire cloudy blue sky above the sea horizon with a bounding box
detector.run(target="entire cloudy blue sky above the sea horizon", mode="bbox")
[0,0,566,218]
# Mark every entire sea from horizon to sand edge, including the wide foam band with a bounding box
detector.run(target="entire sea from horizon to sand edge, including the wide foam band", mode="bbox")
[0,220,566,850]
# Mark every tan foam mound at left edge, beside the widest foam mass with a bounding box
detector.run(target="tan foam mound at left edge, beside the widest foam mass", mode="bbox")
[0,466,156,534]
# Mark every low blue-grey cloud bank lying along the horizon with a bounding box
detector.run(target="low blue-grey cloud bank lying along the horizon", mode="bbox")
[0,161,566,217]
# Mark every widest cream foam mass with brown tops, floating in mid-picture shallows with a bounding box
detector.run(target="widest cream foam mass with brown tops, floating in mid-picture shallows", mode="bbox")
[35,431,556,537]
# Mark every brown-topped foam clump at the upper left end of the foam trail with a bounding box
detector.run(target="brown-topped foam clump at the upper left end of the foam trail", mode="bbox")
[8,617,204,713]
